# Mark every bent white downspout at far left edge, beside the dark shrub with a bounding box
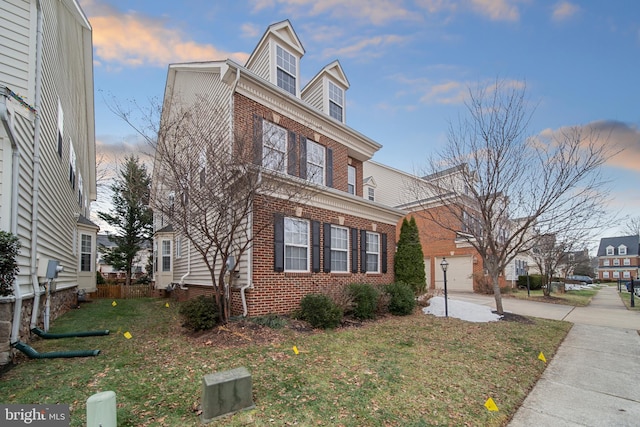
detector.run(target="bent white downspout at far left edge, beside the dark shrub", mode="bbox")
[0,88,22,344]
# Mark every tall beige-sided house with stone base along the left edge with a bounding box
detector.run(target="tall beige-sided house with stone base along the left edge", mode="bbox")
[0,0,98,364]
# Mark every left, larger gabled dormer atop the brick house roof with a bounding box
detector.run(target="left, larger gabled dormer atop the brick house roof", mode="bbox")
[246,19,304,97]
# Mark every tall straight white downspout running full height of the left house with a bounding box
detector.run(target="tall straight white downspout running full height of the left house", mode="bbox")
[29,0,43,329]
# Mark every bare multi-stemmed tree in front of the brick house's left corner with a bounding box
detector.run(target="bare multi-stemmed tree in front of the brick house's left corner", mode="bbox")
[114,98,314,323]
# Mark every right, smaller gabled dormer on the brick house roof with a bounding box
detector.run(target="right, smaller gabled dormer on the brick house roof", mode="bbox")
[301,60,349,123]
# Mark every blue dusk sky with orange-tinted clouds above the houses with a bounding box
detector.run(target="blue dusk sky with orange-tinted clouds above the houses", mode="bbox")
[80,0,640,241]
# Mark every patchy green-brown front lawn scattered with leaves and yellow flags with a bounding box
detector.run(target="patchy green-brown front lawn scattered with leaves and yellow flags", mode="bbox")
[0,299,571,426]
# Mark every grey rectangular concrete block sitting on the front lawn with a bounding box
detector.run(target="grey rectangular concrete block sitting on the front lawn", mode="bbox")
[200,367,255,423]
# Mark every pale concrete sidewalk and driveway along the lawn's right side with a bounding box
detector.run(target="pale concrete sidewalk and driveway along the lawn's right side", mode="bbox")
[450,286,640,427]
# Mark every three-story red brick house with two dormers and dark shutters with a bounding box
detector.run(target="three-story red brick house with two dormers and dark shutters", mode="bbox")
[152,20,403,316]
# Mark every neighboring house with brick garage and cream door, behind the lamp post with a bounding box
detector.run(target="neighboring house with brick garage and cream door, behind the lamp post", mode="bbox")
[363,161,525,291]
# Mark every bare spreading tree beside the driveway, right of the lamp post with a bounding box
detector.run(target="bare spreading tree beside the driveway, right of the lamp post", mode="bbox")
[412,80,608,313]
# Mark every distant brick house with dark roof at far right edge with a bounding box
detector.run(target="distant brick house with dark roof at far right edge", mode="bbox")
[598,234,640,281]
